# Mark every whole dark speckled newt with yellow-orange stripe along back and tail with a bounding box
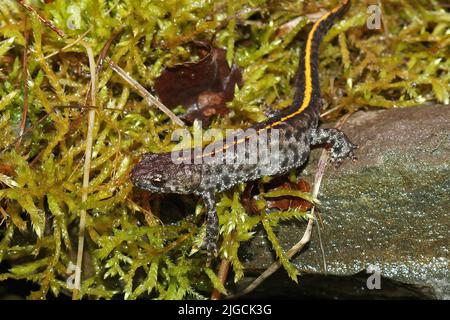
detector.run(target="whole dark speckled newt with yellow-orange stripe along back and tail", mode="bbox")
[131,1,356,254]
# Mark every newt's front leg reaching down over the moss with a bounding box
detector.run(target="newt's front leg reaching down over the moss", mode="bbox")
[203,192,219,260]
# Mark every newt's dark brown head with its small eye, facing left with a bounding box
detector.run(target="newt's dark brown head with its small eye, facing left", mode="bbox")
[131,153,201,193]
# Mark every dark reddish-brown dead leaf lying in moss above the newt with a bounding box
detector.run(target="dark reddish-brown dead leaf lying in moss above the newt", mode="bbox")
[155,42,242,127]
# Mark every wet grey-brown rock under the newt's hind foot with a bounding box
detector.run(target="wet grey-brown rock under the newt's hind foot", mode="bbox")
[241,105,450,299]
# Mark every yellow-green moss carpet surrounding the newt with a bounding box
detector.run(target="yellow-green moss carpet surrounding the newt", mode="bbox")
[0,0,450,299]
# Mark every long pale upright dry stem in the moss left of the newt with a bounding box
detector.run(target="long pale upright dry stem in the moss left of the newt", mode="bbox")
[72,42,97,300]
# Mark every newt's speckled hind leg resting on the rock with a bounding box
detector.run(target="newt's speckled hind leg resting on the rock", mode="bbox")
[311,128,358,164]
